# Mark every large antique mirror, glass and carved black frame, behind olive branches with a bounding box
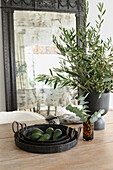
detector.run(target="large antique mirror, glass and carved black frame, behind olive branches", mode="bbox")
[0,0,85,111]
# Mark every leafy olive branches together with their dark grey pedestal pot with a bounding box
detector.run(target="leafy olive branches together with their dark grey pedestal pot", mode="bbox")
[37,1,113,129]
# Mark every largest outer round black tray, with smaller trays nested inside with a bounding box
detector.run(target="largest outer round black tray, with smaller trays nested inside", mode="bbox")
[13,121,81,154]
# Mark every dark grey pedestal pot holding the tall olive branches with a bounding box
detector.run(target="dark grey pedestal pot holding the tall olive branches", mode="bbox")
[85,93,110,130]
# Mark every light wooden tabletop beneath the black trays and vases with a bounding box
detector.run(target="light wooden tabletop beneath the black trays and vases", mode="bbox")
[0,112,113,170]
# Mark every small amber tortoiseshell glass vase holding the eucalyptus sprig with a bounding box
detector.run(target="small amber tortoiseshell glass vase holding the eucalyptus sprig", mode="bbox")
[83,117,94,141]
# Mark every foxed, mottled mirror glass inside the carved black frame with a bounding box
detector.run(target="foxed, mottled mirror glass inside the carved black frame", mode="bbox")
[14,11,76,113]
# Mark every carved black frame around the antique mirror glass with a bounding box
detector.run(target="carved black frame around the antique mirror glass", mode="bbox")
[0,0,84,111]
